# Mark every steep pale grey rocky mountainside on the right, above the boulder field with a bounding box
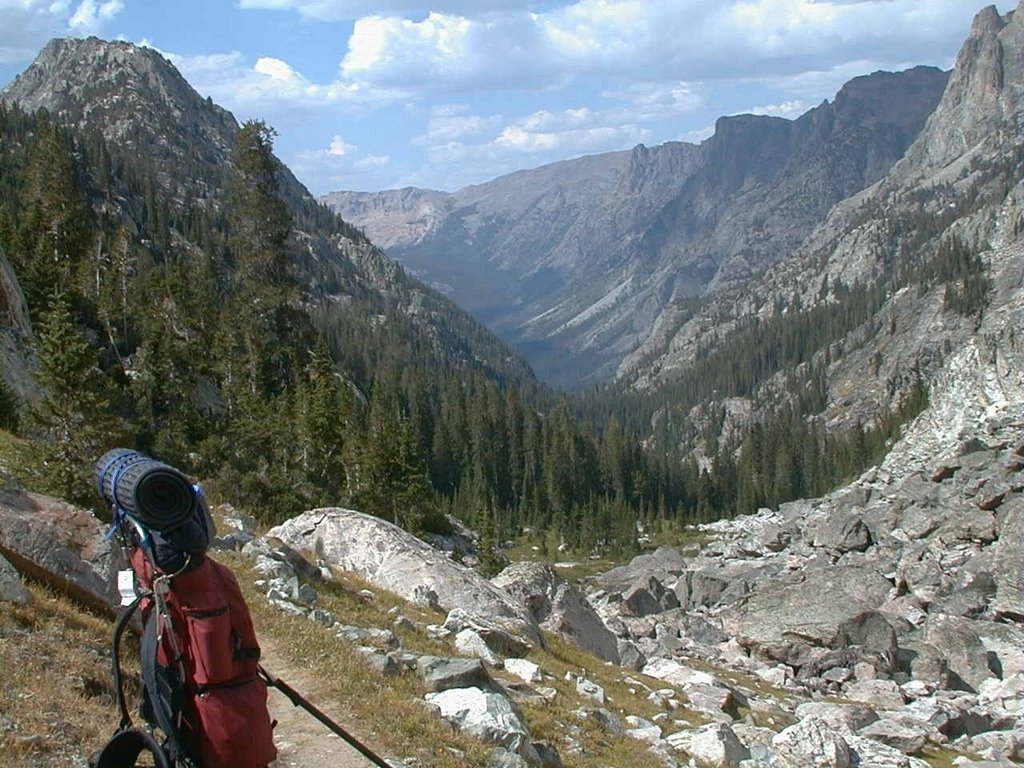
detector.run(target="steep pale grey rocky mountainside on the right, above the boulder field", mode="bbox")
[618,1,1024,444]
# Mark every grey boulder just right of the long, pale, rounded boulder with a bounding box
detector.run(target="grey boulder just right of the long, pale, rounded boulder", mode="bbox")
[490,562,620,664]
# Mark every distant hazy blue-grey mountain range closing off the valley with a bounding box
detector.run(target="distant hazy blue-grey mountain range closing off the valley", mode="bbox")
[325,68,946,386]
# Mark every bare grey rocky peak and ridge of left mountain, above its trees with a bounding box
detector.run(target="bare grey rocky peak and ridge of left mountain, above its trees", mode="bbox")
[0,37,532,391]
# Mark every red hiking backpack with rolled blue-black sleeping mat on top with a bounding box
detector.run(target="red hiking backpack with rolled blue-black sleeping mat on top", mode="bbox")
[93,451,276,768]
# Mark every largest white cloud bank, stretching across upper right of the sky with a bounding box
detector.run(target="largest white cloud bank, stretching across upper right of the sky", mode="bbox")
[333,0,999,92]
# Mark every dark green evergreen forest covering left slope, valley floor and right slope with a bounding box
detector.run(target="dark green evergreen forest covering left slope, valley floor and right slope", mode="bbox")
[0,103,987,567]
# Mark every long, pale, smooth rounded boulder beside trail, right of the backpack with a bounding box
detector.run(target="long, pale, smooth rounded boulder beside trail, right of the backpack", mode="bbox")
[267,508,543,647]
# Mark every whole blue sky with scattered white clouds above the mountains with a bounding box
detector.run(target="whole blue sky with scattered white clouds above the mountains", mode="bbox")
[0,0,1016,195]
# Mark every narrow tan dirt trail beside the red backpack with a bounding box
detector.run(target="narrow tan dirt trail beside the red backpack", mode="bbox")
[260,636,380,768]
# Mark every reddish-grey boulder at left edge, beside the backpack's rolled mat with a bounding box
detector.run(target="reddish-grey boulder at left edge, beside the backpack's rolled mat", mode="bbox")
[0,490,120,611]
